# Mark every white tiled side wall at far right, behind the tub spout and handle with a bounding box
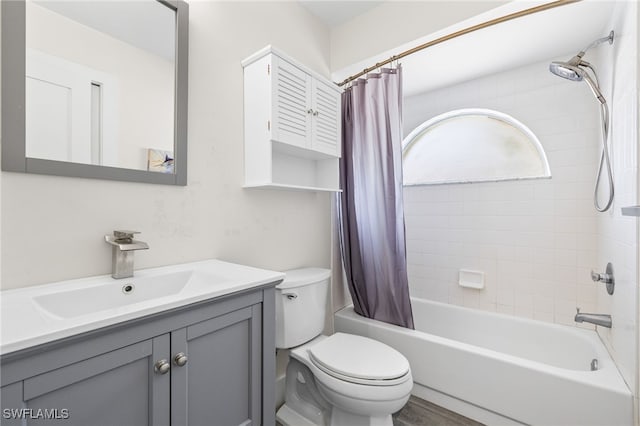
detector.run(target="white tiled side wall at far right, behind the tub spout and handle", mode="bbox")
[597,2,639,412]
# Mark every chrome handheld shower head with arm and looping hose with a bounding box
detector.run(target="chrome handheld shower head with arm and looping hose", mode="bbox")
[549,31,614,212]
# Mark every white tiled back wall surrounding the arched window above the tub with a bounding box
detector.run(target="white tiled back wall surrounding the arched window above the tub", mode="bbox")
[404,57,601,327]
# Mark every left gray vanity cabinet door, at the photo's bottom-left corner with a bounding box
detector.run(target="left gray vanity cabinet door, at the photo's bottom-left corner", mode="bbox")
[2,334,170,426]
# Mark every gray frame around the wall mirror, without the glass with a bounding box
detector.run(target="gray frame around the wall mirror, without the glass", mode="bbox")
[0,0,189,186]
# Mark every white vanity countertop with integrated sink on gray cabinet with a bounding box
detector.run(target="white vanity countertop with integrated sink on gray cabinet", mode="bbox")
[0,259,285,355]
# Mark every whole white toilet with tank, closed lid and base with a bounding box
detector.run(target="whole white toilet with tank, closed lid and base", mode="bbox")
[276,268,413,426]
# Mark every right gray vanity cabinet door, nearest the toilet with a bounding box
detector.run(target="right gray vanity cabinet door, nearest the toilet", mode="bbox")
[171,304,262,426]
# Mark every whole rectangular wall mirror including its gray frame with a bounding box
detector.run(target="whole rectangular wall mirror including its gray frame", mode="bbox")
[2,0,188,185]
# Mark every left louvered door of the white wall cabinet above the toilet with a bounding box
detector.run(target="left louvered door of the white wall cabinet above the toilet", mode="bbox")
[272,56,311,148]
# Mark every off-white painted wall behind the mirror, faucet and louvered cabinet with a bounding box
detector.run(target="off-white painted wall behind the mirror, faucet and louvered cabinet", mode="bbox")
[0,1,330,289]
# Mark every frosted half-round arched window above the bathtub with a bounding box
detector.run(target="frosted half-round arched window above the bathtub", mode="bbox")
[402,108,551,186]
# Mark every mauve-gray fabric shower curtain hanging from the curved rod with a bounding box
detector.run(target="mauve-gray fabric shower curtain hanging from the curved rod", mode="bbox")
[338,67,413,328]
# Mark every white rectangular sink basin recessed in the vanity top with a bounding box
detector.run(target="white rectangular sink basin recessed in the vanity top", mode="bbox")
[33,270,224,318]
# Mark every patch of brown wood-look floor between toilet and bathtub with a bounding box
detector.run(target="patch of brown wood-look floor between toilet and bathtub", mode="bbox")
[393,395,483,426]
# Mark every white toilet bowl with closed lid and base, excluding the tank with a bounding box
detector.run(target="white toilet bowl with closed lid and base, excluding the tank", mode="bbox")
[277,333,413,426]
